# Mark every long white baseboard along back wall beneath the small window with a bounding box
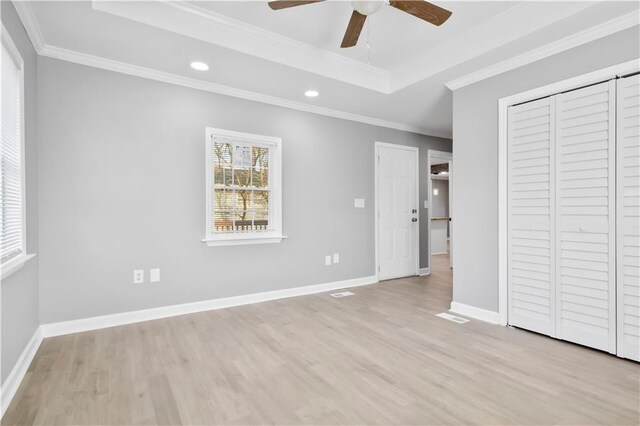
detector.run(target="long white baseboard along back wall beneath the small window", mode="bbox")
[41,276,378,337]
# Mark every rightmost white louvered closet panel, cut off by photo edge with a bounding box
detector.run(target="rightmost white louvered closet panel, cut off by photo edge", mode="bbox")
[617,75,640,361]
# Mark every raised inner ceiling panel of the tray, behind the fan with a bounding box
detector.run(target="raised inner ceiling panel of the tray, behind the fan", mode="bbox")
[190,1,517,70]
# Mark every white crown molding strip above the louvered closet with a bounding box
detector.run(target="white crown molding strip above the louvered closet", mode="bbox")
[446,10,640,90]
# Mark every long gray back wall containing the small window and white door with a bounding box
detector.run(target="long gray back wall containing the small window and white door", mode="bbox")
[38,57,451,323]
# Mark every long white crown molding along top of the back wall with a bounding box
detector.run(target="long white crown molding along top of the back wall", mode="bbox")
[39,45,451,139]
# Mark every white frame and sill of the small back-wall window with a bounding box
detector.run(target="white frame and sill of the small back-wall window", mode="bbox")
[202,127,287,247]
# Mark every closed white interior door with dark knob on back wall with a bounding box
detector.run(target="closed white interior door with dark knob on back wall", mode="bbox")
[377,144,418,280]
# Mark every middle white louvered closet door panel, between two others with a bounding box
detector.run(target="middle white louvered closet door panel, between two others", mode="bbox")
[555,80,616,353]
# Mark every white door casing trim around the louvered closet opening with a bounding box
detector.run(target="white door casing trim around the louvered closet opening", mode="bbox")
[498,58,640,325]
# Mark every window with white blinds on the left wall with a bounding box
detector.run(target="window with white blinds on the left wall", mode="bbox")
[0,27,27,276]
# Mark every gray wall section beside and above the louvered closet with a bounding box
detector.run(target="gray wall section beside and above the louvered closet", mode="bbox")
[452,26,640,311]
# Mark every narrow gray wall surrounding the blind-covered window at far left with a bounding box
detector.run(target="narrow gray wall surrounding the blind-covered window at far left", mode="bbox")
[0,1,39,382]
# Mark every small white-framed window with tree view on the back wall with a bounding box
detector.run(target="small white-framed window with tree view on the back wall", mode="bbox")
[204,128,284,246]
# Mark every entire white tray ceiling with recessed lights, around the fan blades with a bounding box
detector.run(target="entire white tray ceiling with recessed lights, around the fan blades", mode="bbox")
[17,1,638,137]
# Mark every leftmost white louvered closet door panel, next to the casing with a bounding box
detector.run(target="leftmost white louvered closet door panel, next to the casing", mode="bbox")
[507,98,555,336]
